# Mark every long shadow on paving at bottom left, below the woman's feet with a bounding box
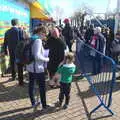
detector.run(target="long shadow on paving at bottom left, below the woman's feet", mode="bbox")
[0,107,61,120]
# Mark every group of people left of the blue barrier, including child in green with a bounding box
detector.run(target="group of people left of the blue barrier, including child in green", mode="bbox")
[4,19,76,110]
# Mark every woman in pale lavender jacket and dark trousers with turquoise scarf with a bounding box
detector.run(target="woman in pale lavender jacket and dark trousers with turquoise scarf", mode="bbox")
[27,26,49,109]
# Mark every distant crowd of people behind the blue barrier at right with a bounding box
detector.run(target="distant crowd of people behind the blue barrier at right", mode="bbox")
[74,24,120,64]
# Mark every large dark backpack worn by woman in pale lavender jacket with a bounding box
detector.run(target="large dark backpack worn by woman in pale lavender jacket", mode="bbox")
[15,39,35,65]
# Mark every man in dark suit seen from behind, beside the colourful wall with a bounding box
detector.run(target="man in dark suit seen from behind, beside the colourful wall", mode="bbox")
[4,19,23,85]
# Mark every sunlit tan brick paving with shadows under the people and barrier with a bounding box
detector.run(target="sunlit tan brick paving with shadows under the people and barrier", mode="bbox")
[0,73,120,120]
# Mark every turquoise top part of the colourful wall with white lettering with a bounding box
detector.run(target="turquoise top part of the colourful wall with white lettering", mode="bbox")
[0,0,30,23]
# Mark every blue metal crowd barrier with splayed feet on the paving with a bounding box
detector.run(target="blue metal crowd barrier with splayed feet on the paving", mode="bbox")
[76,40,116,115]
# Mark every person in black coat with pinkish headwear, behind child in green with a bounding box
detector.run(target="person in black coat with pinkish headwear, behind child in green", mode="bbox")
[47,28,66,86]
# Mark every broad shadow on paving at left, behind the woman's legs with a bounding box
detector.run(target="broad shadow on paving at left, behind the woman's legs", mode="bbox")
[0,78,57,102]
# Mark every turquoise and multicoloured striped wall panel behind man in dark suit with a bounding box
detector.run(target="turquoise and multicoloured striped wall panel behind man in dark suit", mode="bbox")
[0,0,30,44]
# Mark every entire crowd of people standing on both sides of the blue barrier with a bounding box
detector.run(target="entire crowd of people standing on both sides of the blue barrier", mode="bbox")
[4,19,120,109]
